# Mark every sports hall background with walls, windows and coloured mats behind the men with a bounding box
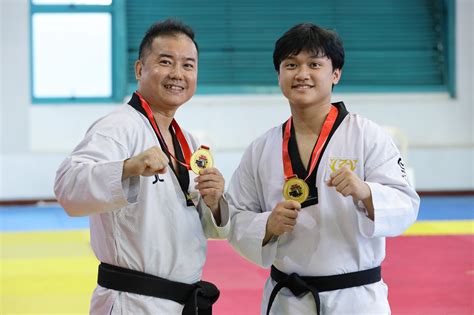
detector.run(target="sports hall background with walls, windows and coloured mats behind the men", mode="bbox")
[0,0,474,315]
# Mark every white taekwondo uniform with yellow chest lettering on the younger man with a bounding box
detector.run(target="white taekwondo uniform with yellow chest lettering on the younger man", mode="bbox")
[226,102,419,315]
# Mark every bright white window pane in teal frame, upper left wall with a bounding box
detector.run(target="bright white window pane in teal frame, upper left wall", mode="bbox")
[31,0,126,103]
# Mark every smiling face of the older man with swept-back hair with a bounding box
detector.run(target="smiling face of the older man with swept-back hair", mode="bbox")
[135,34,198,112]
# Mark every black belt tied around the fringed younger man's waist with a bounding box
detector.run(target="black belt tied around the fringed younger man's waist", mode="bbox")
[267,266,382,315]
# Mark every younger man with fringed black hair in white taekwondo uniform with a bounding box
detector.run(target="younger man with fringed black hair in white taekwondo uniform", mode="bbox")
[227,24,419,315]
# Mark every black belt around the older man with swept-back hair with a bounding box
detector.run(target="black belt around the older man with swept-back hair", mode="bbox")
[97,263,219,315]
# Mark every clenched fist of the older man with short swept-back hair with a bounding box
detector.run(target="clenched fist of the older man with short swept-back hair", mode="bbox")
[122,146,169,180]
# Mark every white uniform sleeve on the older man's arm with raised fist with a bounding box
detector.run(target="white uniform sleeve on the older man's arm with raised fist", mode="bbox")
[54,132,140,216]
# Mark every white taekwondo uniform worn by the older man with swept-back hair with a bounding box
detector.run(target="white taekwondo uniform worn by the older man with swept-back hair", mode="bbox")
[55,95,229,314]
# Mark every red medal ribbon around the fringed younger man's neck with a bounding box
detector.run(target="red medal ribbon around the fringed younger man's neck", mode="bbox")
[282,105,338,181]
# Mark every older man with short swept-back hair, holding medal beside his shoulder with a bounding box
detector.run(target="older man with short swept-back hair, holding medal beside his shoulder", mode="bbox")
[55,20,229,314]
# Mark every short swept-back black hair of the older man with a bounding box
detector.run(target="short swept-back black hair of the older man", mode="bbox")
[138,19,199,59]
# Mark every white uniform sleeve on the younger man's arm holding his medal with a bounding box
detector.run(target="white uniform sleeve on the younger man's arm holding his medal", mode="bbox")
[226,146,278,267]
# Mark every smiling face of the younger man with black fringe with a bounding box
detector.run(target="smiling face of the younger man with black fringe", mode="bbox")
[278,50,341,107]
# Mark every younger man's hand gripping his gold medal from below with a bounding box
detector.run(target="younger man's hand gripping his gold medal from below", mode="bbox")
[262,200,301,246]
